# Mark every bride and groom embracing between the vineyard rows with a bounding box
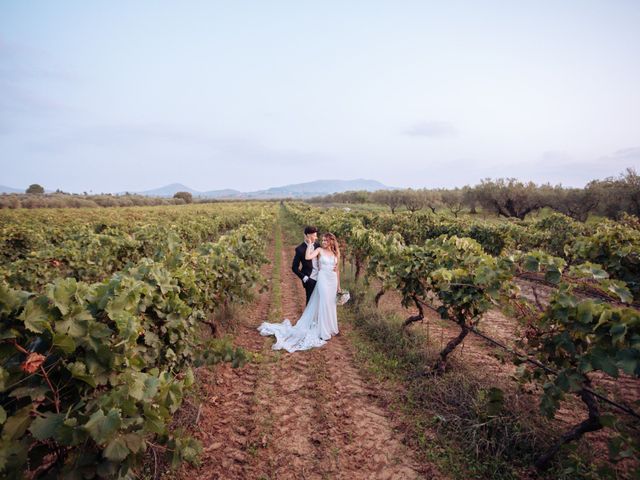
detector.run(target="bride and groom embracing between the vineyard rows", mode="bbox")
[258,227,341,352]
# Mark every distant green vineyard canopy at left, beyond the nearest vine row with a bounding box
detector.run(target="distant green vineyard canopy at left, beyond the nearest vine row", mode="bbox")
[0,204,263,291]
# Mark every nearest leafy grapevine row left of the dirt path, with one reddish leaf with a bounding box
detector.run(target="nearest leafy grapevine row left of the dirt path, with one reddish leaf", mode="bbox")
[0,204,273,478]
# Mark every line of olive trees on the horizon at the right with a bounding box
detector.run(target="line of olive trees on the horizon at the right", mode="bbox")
[311,168,640,221]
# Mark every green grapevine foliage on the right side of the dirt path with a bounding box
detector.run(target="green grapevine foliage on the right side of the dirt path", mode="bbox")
[286,200,640,472]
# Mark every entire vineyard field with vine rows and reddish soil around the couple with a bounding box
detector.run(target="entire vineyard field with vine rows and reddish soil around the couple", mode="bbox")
[0,202,640,479]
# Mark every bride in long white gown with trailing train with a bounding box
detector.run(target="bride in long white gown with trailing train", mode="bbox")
[258,233,340,353]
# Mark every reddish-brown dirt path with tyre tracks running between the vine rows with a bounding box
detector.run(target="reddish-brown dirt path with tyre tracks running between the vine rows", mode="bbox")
[174,226,444,480]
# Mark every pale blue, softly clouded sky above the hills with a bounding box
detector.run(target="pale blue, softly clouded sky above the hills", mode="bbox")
[0,0,640,193]
